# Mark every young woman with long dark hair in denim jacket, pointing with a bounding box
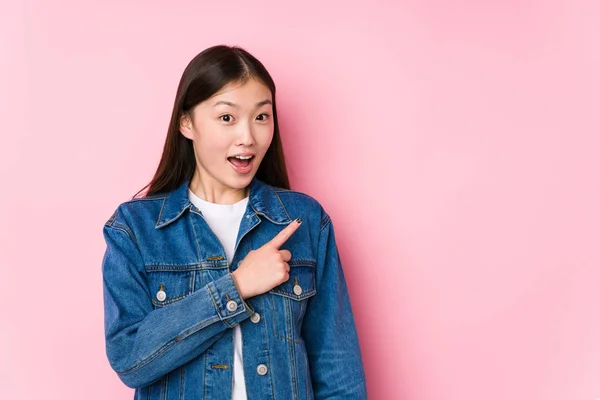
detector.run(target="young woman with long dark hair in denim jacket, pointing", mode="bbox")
[102,46,367,400]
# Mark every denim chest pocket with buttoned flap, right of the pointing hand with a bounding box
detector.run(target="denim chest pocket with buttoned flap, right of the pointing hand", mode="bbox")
[269,260,317,343]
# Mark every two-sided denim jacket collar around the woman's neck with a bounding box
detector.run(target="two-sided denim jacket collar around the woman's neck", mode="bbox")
[155,176,292,228]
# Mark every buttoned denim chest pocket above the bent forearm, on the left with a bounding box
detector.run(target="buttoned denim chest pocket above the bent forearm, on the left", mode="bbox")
[146,266,195,308]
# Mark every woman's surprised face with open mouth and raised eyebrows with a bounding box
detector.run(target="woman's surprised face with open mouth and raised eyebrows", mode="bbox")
[180,78,274,198]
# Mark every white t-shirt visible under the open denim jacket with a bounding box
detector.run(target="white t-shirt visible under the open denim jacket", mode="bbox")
[188,188,248,400]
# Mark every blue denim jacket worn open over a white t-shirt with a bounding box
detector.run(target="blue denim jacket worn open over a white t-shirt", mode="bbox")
[102,177,367,400]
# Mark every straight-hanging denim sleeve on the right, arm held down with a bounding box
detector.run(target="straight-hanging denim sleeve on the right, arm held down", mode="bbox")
[302,214,367,400]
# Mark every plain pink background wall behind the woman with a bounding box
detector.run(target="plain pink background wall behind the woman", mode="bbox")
[0,0,600,400]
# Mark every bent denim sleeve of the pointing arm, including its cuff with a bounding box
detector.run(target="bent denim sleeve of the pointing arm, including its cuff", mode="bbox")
[102,221,253,388]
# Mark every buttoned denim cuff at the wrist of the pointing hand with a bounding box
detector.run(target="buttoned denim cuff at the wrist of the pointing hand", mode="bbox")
[206,272,254,328]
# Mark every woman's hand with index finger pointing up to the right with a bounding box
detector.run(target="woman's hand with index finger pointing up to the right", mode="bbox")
[232,218,302,299]
